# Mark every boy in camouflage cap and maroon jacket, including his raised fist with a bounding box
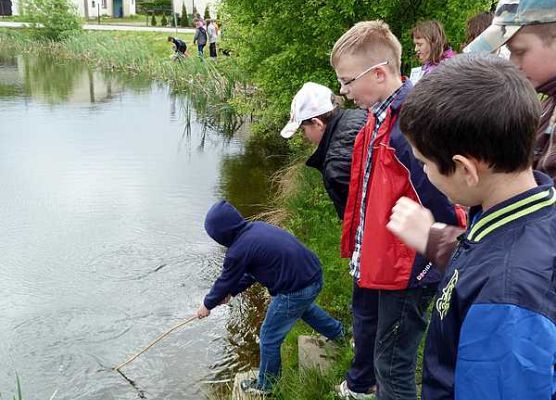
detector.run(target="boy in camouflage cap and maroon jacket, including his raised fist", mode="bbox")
[391,0,556,266]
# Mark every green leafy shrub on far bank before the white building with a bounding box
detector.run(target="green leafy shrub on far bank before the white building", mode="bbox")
[25,0,81,41]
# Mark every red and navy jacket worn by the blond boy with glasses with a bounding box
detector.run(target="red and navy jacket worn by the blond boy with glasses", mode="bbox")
[341,80,465,290]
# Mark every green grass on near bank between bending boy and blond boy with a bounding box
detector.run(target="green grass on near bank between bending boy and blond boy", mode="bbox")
[258,160,353,400]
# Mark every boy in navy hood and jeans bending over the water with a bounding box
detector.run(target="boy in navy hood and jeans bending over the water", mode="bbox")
[197,201,343,394]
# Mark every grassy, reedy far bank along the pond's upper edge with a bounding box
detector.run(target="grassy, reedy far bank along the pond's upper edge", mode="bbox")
[0,29,250,133]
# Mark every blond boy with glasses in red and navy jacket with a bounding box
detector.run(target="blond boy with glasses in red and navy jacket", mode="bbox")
[330,20,457,400]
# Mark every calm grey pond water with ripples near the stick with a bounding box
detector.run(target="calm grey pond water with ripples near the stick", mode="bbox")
[0,55,281,400]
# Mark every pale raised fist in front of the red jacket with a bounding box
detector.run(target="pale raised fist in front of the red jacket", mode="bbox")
[386,197,434,254]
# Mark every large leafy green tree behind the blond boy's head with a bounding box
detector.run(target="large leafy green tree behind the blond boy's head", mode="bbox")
[219,0,492,129]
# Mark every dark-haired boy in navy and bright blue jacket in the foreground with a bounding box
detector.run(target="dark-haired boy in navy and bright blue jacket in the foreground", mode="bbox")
[400,54,556,400]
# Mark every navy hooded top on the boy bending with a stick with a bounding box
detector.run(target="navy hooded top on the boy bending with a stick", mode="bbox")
[204,201,322,310]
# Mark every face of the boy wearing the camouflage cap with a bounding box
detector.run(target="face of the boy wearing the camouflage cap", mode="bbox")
[507,30,556,87]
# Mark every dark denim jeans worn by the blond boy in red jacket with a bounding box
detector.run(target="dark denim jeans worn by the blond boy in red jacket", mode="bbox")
[347,284,436,400]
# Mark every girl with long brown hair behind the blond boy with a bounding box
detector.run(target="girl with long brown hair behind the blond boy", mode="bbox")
[410,21,456,84]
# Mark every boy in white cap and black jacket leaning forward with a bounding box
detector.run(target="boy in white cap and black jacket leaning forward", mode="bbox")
[280,82,367,219]
